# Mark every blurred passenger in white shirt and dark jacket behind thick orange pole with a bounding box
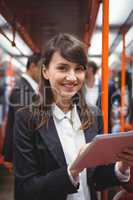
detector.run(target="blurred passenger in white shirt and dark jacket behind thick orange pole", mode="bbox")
[83,61,115,132]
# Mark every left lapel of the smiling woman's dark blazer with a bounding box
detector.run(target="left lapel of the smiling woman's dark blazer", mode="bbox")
[39,117,67,167]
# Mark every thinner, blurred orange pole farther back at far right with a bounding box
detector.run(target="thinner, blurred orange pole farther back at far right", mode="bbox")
[120,31,126,131]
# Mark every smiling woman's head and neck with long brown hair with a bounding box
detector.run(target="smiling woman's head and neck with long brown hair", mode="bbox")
[37,34,94,127]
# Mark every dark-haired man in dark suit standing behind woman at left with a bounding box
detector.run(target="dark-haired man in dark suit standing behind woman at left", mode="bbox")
[3,53,41,162]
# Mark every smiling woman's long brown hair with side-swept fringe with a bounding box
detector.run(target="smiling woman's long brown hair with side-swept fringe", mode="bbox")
[31,33,94,128]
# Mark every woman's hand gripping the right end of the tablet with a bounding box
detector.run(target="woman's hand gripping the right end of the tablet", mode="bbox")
[118,147,133,173]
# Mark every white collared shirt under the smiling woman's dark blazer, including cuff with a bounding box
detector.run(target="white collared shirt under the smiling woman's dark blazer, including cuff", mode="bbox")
[52,104,130,200]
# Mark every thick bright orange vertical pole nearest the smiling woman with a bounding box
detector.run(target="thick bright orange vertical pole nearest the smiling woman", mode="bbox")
[102,0,109,200]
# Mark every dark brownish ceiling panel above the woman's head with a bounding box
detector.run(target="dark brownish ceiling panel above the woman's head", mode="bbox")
[1,0,92,51]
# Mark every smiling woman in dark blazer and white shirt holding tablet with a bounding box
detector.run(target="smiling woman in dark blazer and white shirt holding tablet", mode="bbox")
[14,34,133,200]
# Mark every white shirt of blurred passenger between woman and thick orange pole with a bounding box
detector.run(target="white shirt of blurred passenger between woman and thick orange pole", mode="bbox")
[83,76,99,106]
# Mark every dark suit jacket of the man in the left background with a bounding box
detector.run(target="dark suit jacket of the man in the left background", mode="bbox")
[3,77,35,162]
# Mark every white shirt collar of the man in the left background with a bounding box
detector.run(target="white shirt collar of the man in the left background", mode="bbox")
[22,74,39,94]
